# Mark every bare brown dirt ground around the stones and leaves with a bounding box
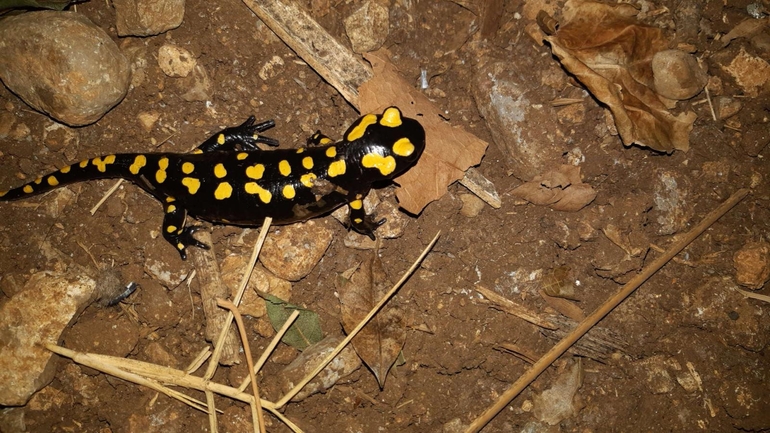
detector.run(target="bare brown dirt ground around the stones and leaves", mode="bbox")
[0,0,770,433]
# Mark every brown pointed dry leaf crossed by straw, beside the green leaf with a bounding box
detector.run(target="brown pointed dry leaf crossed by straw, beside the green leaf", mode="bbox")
[337,250,406,388]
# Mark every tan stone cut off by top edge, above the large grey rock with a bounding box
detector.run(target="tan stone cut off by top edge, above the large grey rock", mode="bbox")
[112,0,185,36]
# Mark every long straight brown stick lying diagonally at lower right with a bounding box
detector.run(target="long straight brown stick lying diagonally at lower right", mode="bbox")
[464,189,749,433]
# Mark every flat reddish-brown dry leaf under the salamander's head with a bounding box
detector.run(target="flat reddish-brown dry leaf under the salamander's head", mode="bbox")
[358,51,488,214]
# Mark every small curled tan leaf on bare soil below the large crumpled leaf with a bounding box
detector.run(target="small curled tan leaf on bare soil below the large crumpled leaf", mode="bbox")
[513,164,596,212]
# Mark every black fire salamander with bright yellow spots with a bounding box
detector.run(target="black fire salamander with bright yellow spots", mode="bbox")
[0,107,425,260]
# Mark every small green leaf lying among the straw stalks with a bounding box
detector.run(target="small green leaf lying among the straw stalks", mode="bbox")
[263,294,323,350]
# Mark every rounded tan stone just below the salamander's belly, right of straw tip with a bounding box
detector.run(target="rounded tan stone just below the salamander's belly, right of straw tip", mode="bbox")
[259,220,333,281]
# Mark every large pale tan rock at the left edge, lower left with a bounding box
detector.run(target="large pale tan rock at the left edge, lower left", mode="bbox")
[0,272,96,406]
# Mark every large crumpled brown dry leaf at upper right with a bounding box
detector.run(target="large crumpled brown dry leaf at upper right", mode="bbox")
[546,0,696,152]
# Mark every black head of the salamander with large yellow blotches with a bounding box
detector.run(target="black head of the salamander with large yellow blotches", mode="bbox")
[343,107,425,181]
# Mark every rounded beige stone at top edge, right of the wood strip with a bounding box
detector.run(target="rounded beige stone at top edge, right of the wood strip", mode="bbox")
[345,1,390,54]
